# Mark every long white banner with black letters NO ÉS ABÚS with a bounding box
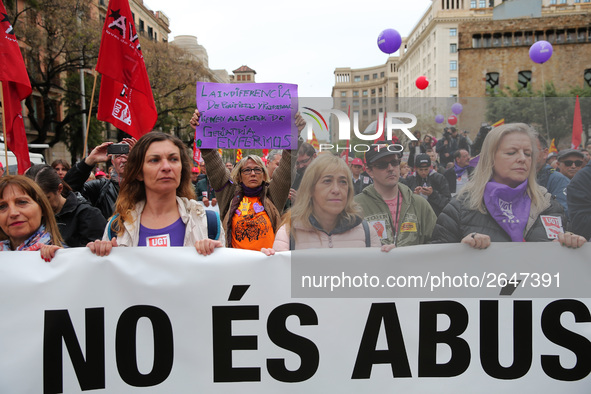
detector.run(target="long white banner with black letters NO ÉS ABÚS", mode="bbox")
[0,243,591,394]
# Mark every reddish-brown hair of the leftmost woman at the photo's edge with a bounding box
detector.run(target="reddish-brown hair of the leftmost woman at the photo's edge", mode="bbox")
[0,175,64,246]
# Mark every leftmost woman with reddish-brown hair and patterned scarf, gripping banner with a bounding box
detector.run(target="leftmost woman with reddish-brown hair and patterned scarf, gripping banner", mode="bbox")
[0,175,62,261]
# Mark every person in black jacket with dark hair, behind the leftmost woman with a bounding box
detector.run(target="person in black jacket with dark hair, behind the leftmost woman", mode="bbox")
[26,164,107,247]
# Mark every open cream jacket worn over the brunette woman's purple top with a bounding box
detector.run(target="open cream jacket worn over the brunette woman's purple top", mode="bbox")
[103,196,225,246]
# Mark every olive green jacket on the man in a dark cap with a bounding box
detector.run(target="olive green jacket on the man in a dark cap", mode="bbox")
[355,183,437,247]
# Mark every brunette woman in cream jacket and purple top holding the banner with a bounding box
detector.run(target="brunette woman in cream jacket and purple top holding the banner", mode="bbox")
[80,132,224,256]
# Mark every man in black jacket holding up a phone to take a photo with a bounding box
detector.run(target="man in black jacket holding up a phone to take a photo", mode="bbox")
[64,138,136,219]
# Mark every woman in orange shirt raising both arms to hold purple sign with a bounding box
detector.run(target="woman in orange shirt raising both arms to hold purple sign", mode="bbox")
[191,110,305,251]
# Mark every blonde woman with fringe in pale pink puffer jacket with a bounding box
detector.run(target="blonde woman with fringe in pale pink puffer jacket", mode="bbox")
[270,153,382,254]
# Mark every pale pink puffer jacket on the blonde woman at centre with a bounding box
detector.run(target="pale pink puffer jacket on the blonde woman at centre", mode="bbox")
[273,217,381,252]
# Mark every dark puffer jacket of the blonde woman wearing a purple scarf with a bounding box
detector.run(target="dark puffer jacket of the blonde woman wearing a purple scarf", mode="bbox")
[431,186,566,244]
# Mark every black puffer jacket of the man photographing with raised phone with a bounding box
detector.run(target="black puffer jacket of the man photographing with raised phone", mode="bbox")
[64,160,119,219]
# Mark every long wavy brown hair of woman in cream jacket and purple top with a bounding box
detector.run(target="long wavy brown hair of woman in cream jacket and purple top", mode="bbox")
[112,131,196,234]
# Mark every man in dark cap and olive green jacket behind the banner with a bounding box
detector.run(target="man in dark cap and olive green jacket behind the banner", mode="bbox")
[355,145,437,247]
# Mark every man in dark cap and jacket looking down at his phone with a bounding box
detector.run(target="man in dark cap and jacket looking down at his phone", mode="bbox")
[403,153,451,216]
